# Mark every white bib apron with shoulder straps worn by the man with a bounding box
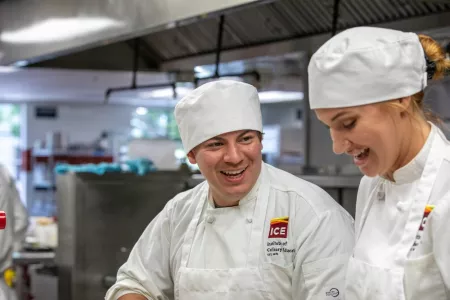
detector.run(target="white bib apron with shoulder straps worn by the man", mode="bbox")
[175,168,272,300]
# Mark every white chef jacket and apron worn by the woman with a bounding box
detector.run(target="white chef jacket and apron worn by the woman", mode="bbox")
[346,125,450,300]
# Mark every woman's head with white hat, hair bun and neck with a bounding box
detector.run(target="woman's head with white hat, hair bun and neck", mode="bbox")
[309,28,450,180]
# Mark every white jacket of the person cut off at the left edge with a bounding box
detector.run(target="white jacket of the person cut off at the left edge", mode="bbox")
[0,164,28,300]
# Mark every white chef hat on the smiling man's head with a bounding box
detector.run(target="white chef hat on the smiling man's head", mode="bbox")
[175,80,262,152]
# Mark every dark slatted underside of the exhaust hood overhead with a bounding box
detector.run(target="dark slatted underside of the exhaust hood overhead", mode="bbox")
[20,0,450,70]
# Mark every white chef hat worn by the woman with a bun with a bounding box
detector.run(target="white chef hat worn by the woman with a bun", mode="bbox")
[308,27,427,109]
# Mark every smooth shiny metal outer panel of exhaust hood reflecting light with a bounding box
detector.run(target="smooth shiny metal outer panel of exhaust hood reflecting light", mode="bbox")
[0,0,261,65]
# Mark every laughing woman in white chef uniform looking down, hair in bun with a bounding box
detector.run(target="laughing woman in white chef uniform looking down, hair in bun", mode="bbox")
[309,27,450,300]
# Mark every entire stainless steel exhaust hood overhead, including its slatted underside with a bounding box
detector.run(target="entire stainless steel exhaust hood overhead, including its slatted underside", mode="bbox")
[0,0,450,71]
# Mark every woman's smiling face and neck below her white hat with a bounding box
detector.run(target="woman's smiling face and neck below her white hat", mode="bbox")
[316,99,429,178]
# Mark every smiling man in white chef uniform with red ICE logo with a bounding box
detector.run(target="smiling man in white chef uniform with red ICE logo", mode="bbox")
[106,80,354,300]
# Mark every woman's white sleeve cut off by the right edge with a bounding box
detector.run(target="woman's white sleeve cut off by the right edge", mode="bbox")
[432,193,450,290]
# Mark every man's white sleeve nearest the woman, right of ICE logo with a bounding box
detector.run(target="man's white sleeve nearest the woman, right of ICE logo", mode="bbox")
[292,208,354,300]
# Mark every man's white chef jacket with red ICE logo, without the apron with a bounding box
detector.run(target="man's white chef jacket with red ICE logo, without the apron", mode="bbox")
[106,163,354,300]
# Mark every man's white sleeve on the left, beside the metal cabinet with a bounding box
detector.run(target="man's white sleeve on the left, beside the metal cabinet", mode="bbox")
[105,201,173,300]
